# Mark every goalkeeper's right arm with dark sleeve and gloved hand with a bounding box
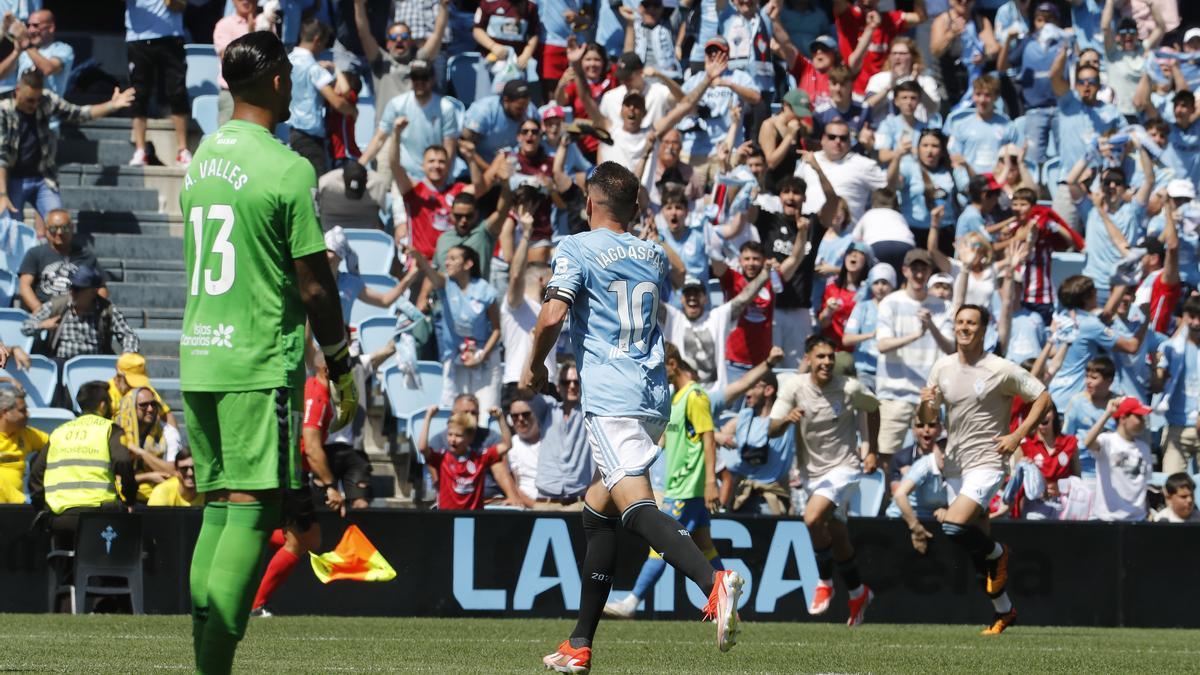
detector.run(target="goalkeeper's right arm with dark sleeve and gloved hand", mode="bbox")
[295,251,359,431]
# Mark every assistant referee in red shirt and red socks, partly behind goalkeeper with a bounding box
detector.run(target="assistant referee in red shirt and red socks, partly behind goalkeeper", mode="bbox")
[251,362,346,616]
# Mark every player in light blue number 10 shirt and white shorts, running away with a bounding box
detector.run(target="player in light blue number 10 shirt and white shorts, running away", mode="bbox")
[521,162,744,674]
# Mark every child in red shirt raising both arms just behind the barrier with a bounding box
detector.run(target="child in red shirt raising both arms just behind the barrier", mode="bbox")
[416,406,512,510]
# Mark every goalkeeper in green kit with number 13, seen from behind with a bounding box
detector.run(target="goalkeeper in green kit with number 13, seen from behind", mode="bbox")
[179,32,356,674]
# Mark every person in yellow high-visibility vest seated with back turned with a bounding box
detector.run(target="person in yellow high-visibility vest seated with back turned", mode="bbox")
[29,381,138,548]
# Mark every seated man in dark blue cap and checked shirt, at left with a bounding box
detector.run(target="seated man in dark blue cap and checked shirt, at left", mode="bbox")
[20,265,142,360]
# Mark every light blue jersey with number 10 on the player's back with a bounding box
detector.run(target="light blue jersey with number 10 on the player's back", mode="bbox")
[547,228,671,419]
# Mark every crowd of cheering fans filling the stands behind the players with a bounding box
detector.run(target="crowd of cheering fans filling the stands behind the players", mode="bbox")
[0,0,1200,521]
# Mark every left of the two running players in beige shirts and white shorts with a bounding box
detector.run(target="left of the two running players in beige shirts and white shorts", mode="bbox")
[770,335,880,627]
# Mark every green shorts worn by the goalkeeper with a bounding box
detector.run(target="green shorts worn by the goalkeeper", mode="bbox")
[184,388,304,492]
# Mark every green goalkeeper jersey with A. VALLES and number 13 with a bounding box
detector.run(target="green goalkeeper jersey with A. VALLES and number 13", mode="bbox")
[179,120,325,392]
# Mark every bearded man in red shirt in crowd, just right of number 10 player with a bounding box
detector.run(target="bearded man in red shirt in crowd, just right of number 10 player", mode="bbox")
[713,241,775,369]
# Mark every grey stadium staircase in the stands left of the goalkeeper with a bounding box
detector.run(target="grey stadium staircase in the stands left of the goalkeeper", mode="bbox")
[43,118,407,504]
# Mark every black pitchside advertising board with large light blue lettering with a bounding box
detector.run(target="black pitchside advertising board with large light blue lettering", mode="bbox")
[0,507,1200,639]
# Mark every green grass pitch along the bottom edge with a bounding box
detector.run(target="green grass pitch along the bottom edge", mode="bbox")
[0,614,1200,674]
